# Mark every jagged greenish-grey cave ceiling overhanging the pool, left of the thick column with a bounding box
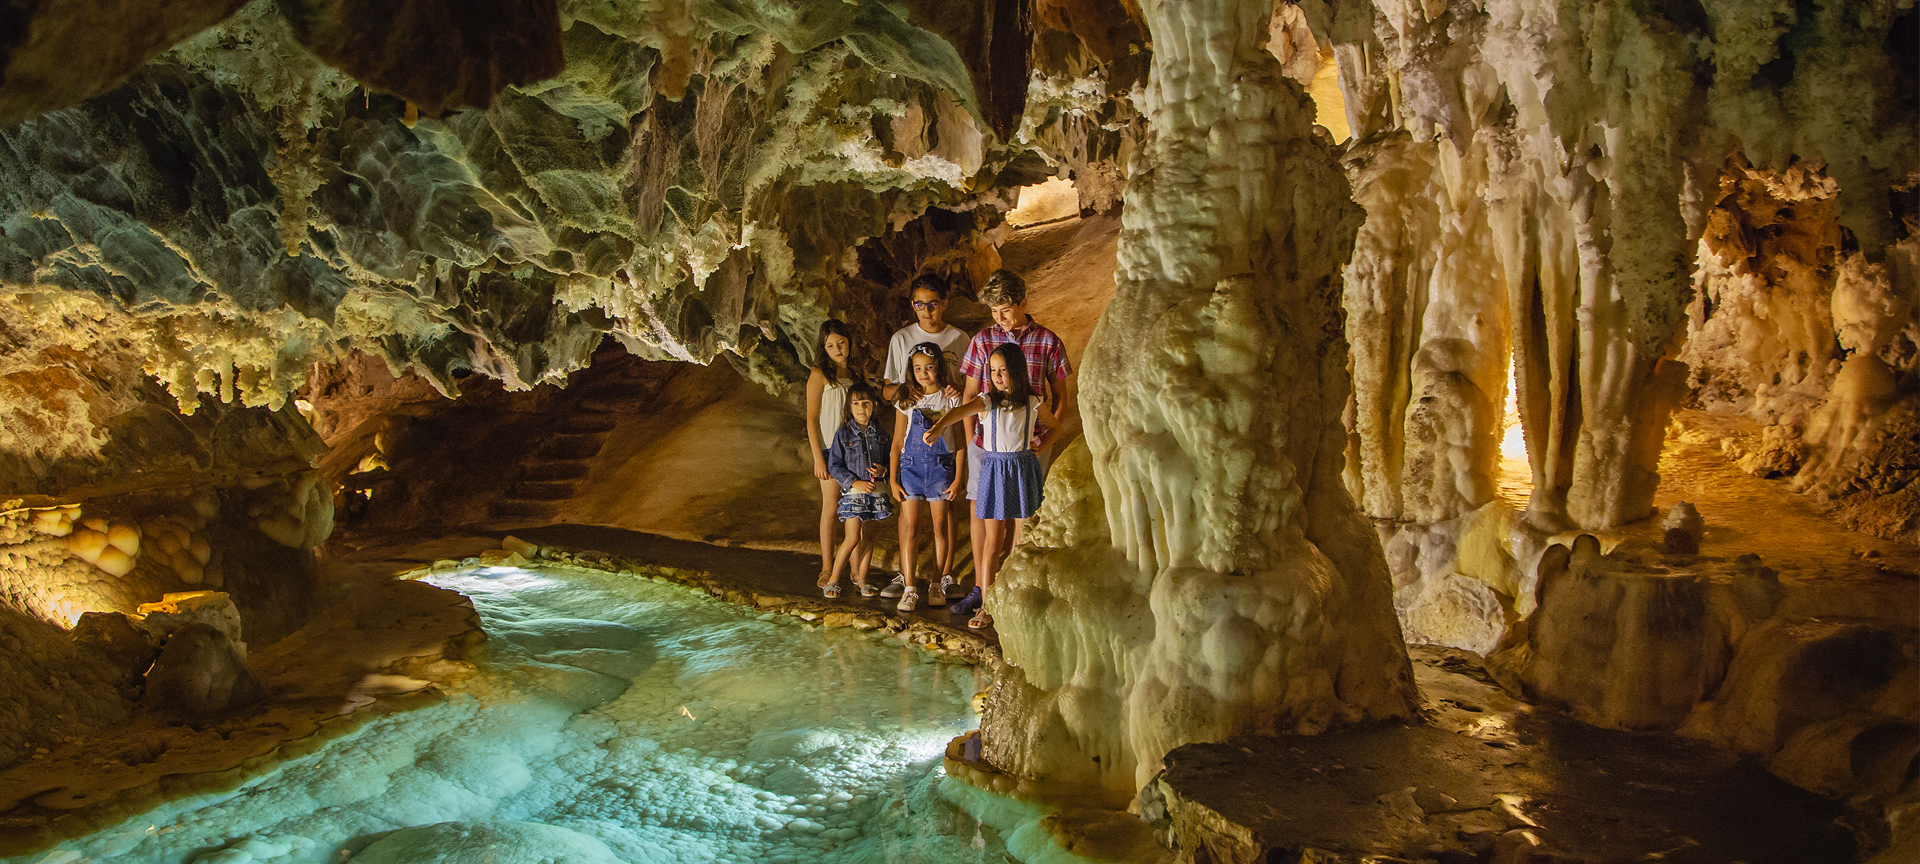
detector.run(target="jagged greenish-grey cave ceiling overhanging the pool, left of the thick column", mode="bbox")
[0,0,1098,485]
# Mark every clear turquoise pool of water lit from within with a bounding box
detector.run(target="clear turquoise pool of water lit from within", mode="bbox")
[13,566,1008,864]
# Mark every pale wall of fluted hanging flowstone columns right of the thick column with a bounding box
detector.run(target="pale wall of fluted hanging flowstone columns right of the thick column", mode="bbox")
[1309,0,1920,528]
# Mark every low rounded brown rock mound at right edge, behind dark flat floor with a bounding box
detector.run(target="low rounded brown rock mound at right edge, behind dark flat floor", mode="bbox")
[1488,536,1920,804]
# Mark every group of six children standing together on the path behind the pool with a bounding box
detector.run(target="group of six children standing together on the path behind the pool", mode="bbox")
[806,271,1071,628]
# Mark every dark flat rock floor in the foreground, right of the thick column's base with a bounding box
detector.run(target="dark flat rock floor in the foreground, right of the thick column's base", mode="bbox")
[1154,647,1857,864]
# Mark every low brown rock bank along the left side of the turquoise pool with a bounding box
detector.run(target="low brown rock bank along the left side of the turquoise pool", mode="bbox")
[0,582,486,856]
